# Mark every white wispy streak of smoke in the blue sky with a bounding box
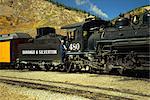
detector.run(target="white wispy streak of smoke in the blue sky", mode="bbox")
[75,0,108,19]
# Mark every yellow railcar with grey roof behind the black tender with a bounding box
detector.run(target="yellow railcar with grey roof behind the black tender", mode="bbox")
[0,33,32,68]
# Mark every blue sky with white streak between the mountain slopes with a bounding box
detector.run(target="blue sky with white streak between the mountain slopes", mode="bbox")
[54,0,150,20]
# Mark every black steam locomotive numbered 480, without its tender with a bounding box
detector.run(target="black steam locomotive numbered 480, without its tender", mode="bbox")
[62,11,150,74]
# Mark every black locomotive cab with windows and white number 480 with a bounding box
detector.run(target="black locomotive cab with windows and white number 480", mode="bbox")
[61,19,107,54]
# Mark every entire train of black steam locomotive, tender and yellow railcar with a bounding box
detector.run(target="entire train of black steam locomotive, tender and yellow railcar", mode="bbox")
[0,12,150,74]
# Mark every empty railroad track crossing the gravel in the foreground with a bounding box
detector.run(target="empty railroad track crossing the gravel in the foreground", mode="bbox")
[0,76,150,100]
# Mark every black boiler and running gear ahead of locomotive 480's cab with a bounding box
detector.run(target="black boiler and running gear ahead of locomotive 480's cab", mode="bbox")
[97,11,150,73]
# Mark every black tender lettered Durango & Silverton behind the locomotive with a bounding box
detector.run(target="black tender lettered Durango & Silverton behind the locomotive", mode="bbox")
[17,27,61,70]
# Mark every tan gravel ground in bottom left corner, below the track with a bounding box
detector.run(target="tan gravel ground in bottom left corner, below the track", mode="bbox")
[0,83,88,100]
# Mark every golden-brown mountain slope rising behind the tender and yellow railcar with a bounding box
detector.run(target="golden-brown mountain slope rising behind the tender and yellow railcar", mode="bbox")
[0,0,88,37]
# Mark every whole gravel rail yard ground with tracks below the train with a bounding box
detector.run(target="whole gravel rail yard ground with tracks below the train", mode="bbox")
[0,70,150,100]
